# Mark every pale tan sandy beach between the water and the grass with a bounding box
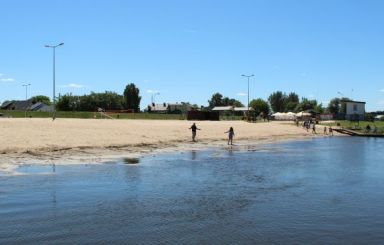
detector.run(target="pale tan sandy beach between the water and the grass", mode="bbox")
[0,118,321,170]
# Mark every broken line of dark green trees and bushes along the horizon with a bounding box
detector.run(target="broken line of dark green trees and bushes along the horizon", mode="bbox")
[6,83,356,115]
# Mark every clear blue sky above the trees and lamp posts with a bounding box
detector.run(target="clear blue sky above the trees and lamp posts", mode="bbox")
[0,0,384,111]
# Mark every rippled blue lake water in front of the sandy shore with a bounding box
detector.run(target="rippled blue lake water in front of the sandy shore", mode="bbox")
[0,137,384,244]
